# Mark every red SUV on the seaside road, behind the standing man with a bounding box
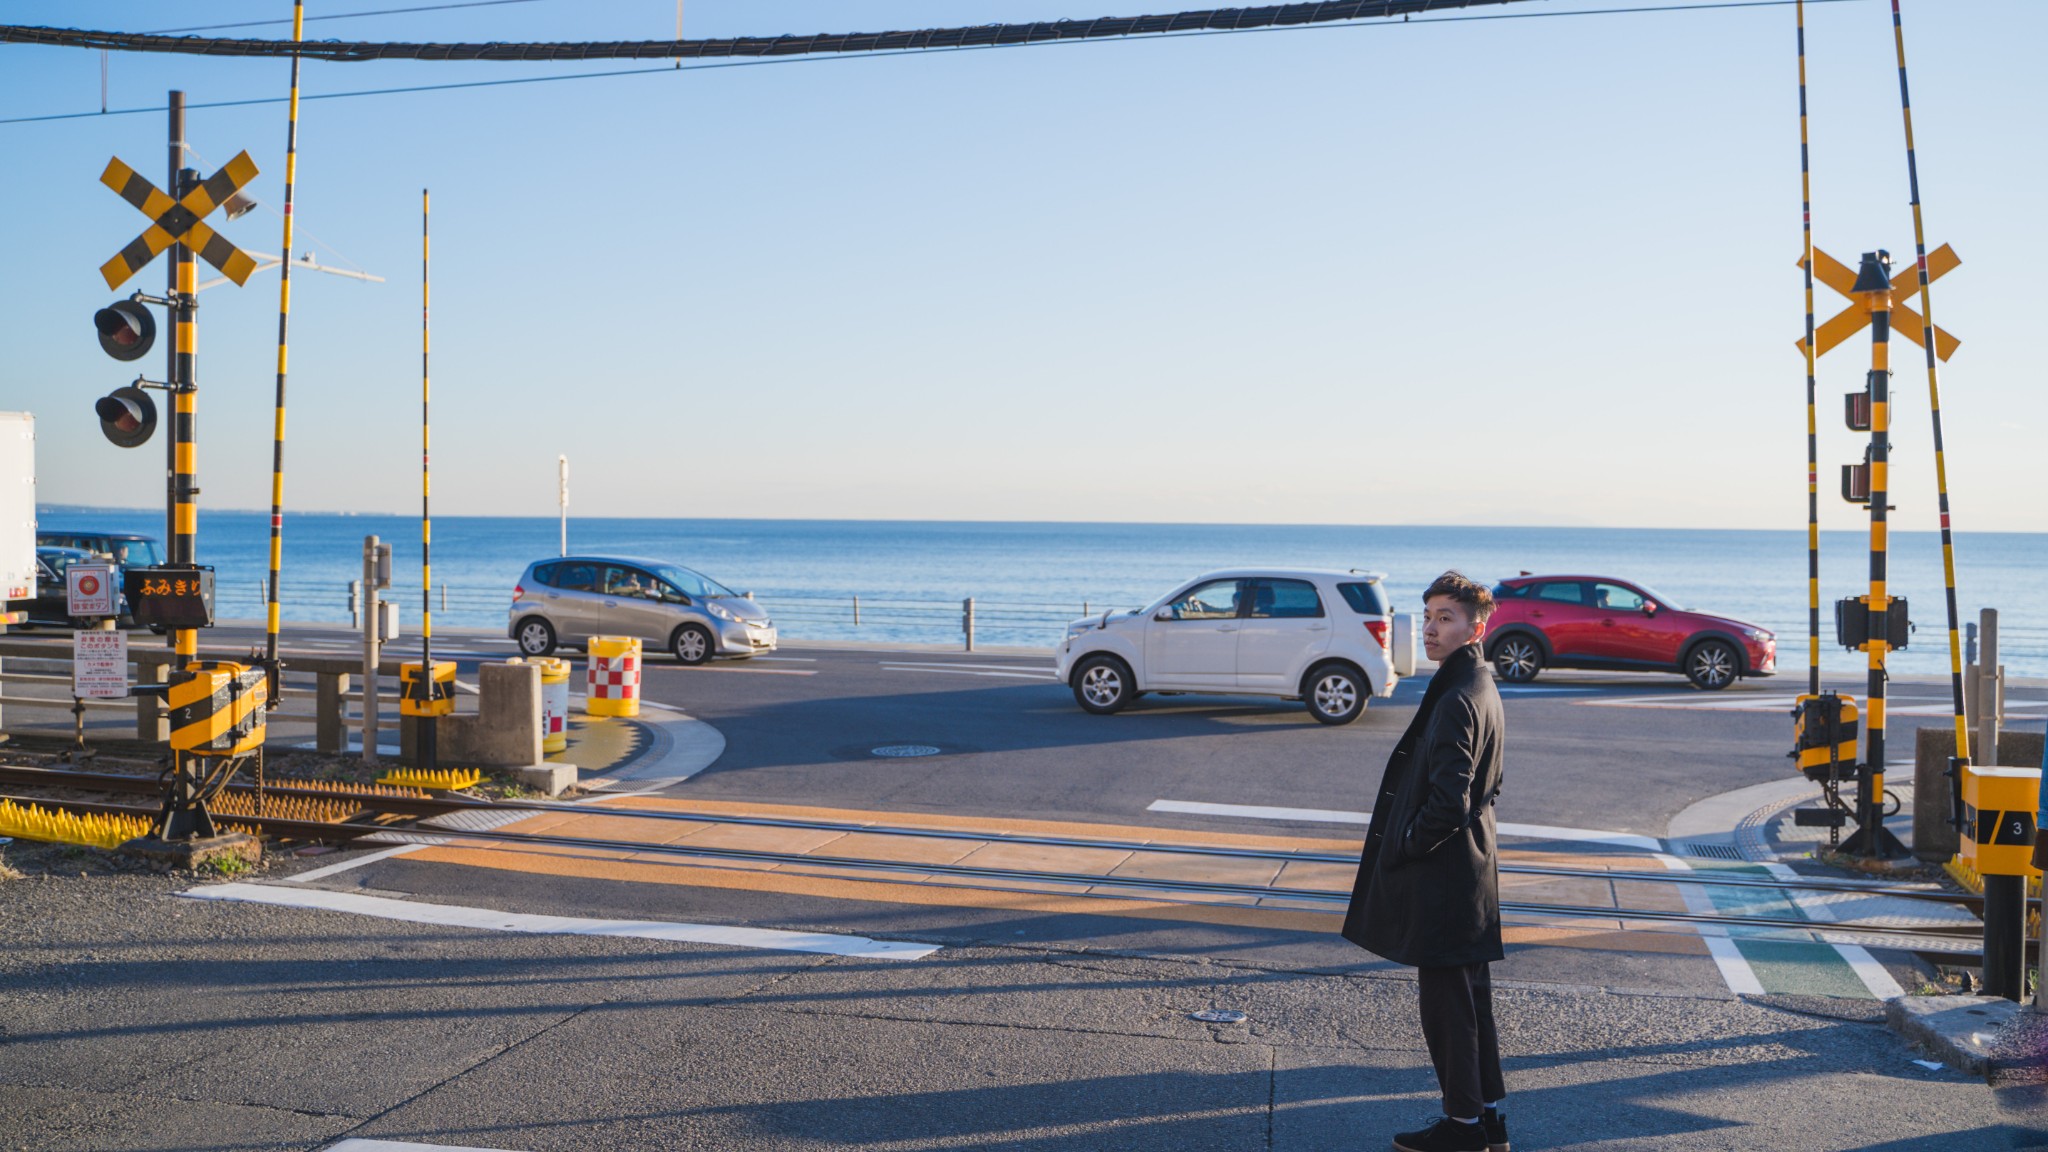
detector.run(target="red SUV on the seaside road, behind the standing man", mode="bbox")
[1487,576,1778,689]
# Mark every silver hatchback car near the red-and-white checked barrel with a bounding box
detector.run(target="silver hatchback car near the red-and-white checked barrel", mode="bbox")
[508,556,776,664]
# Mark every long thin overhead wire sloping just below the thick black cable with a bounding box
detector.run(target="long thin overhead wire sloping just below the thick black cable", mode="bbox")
[0,0,1874,125]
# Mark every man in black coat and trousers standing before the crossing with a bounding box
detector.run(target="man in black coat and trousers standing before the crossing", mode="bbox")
[1343,572,1507,1152]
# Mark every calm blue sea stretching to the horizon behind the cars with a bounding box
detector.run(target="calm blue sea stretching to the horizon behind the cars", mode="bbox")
[39,506,2048,676]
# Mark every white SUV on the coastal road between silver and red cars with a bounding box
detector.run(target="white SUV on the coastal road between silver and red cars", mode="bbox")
[1057,568,1399,724]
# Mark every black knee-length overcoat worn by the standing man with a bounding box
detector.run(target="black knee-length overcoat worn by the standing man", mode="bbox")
[1343,644,1503,968]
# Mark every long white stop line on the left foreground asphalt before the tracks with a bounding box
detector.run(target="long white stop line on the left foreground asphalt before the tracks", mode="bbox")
[178,883,938,959]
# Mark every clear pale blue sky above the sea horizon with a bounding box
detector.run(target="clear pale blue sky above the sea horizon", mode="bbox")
[0,0,2048,531]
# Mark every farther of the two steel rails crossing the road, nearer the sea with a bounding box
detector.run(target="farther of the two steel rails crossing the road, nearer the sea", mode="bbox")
[0,765,2015,908]
